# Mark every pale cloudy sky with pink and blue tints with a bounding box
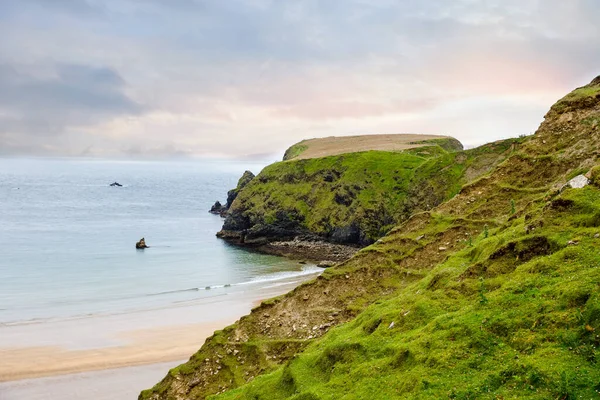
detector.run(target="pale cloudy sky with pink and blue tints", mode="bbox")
[0,0,600,159]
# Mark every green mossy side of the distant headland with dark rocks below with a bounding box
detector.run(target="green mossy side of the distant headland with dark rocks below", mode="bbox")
[220,139,515,245]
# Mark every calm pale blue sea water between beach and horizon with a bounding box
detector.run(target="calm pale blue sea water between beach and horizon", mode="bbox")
[0,159,314,325]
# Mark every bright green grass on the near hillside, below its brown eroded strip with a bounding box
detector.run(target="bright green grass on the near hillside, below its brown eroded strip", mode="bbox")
[211,187,600,400]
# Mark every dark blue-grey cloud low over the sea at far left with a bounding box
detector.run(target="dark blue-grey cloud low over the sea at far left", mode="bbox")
[0,64,145,151]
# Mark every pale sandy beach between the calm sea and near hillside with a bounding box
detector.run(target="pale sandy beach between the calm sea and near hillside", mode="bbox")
[0,274,317,399]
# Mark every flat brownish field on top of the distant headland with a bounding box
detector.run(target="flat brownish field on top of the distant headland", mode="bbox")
[283,134,462,161]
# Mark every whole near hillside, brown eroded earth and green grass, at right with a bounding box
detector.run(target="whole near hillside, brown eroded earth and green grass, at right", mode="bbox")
[140,78,600,400]
